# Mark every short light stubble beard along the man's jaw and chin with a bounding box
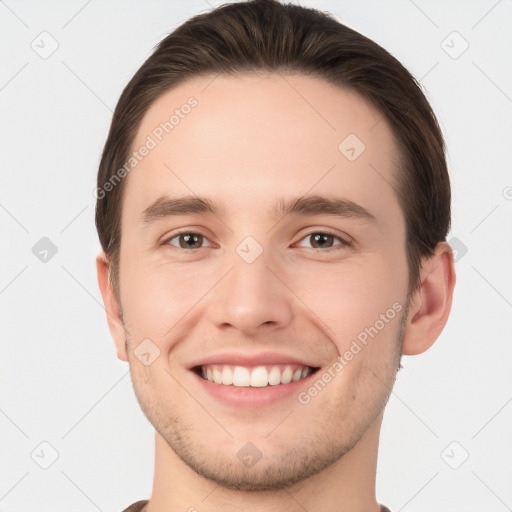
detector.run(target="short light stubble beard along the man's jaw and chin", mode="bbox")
[123,307,408,491]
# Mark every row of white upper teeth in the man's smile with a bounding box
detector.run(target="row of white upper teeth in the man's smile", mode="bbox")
[201,364,312,388]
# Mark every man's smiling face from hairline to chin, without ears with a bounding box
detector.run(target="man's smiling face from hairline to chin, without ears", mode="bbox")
[120,74,408,490]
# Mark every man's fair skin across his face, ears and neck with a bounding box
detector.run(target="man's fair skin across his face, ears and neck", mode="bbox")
[97,74,455,512]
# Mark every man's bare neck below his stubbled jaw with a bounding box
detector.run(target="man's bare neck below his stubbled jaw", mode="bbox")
[146,413,382,512]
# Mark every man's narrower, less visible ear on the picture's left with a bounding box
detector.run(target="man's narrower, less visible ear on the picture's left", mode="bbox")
[96,251,128,361]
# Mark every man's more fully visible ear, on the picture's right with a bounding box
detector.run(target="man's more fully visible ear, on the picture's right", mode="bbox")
[402,242,455,355]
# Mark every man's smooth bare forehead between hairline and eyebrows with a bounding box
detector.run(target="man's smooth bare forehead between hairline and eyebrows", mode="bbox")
[123,73,399,222]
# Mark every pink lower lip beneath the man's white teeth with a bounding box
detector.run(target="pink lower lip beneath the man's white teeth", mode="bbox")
[190,371,317,407]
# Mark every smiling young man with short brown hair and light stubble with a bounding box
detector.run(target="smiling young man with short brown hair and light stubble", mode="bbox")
[96,0,455,512]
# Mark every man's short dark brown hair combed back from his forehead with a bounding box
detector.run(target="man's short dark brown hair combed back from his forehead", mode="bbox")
[96,0,450,298]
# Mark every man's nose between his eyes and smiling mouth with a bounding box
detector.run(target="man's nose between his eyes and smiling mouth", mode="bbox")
[208,247,294,336]
